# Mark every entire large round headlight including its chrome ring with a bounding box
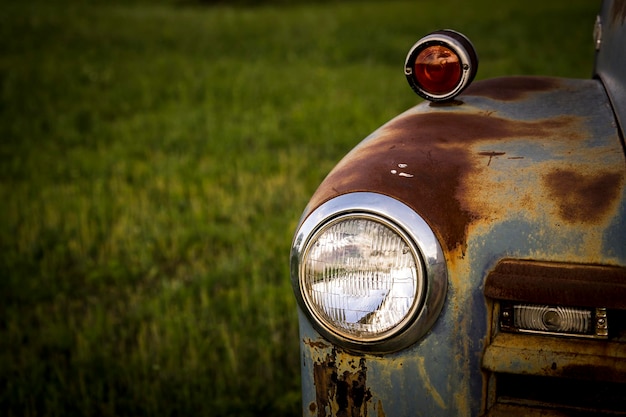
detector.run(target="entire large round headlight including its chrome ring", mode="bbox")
[291,192,447,353]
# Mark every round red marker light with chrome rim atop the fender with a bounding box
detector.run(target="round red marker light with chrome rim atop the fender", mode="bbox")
[404,29,478,101]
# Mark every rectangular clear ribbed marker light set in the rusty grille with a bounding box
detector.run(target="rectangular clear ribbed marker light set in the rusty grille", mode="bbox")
[500,303,608,338]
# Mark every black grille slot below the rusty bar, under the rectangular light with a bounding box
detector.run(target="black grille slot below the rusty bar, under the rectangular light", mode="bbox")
[496,374,626,415]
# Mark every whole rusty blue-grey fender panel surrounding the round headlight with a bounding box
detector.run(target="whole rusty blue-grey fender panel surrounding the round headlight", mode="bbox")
[300,77,626,417]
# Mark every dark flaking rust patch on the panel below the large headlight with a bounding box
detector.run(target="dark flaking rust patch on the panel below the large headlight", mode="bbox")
[309,349,372,417]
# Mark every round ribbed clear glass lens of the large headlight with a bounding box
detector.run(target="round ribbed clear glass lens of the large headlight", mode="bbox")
[300,215,424,341]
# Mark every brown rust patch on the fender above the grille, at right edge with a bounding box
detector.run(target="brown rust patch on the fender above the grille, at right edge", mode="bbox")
[544,169,623,223]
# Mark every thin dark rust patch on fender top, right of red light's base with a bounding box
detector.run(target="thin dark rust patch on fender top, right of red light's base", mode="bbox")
[463,77,560,101]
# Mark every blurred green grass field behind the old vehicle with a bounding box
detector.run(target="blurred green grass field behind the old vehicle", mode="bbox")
[0,0,599,416]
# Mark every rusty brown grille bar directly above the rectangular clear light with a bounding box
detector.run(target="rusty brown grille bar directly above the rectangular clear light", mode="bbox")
[485,260,626,308]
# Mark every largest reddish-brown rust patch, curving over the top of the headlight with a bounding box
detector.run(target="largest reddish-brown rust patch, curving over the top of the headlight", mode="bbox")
[310,110,580,253]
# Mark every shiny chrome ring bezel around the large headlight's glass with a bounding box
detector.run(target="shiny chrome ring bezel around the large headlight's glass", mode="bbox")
[291,192,447,353]
